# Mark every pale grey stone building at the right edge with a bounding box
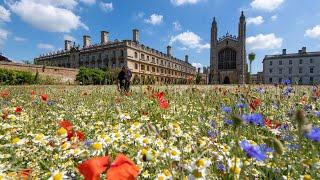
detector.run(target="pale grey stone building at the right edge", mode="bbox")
[263,47,320,85]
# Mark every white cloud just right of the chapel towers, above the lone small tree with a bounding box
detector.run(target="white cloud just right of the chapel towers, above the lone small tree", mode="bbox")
[246,33,283,50]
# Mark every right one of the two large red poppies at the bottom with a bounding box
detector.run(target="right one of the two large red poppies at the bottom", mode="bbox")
[106,154,139,180]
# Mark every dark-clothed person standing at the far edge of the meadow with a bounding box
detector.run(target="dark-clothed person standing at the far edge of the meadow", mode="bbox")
[118,66,132,92]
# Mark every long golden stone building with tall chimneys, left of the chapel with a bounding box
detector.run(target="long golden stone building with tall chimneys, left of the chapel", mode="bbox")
[34,29,196,83]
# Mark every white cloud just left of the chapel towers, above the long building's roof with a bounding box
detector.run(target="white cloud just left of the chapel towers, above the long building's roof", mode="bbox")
[170,31,210,52]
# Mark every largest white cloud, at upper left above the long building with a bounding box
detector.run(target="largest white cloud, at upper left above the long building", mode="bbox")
[9,0,89,32]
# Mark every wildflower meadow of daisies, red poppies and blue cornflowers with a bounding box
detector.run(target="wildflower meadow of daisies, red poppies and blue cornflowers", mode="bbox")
[0,85,320,180]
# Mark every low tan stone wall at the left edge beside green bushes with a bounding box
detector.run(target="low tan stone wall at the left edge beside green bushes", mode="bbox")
[0,62,79,84]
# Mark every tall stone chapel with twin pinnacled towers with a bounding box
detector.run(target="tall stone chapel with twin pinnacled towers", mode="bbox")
[210,12,249,84]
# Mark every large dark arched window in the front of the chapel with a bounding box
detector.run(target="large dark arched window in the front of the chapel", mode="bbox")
[218,48,237,69]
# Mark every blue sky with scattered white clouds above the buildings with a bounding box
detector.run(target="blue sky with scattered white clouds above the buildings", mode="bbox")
[0,0,320,72]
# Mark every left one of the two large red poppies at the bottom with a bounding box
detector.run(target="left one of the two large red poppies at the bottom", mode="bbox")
[78,156,109,180]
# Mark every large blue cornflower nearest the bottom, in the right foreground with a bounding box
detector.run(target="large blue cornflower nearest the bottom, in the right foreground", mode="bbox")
[240,140,272,161]
